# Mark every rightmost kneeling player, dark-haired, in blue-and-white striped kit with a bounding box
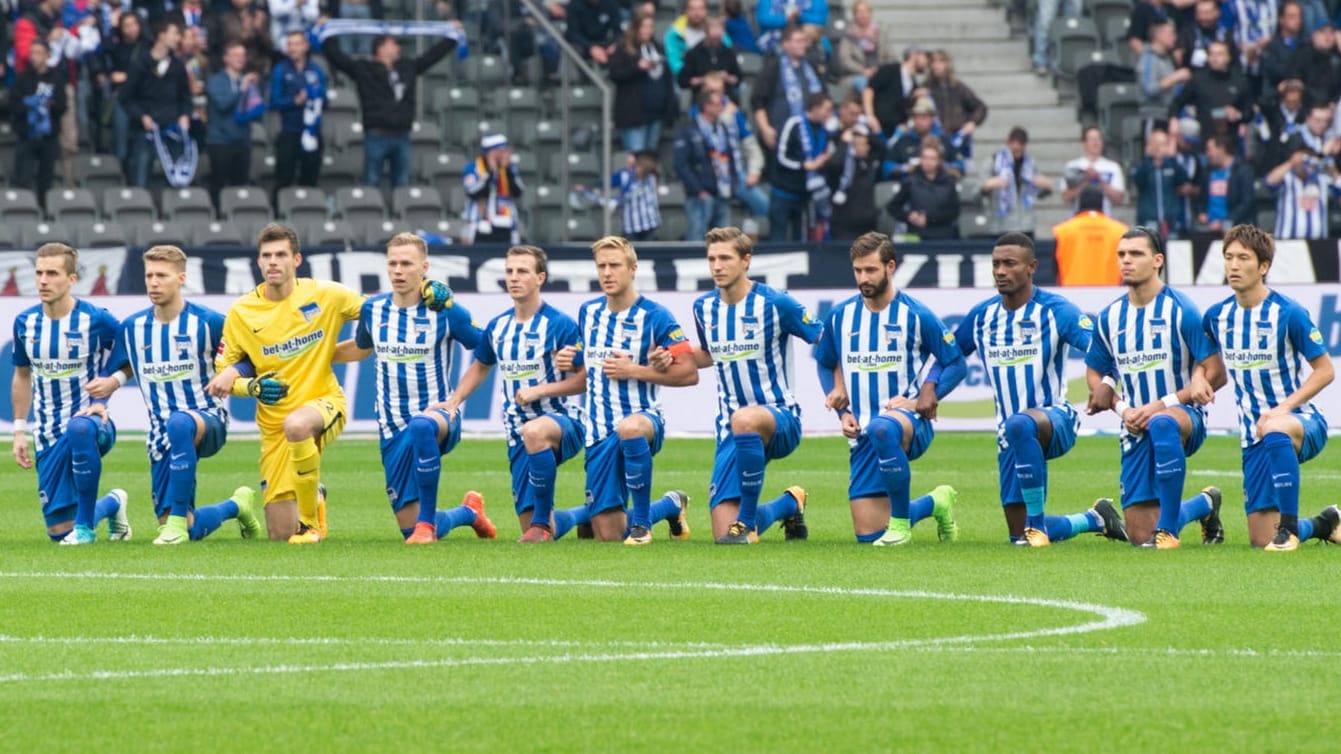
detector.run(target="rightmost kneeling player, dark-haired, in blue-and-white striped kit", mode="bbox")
[1204,225,1341,544]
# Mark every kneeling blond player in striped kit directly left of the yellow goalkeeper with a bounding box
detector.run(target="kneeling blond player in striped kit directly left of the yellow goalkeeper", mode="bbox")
[86,246,261,545]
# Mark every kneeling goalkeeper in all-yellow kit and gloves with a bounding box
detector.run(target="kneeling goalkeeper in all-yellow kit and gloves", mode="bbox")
[207,223,363,545]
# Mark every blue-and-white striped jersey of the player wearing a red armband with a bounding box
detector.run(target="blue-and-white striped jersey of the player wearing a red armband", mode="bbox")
[574,297,691,447]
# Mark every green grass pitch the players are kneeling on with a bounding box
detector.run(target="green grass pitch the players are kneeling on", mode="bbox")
[0,433,1341,753]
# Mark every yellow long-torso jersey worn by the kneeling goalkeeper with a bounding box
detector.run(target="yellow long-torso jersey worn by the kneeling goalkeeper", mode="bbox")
[216,278,363,427]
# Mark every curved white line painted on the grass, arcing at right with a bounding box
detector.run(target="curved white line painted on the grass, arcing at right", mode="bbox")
[0,572,1145,683]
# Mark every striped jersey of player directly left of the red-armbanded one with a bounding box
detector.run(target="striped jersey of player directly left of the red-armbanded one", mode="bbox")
[475,303,582,445]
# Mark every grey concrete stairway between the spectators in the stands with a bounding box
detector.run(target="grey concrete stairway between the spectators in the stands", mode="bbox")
[870,0,1133,239]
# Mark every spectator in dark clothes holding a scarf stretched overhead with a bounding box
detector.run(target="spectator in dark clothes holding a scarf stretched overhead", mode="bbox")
[322,21,460,188]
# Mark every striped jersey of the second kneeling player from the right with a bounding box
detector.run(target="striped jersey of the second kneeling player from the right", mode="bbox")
[1085,286,1220,449]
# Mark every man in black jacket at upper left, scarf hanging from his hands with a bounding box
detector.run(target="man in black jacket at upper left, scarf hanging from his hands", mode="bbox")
[121,20,190,186]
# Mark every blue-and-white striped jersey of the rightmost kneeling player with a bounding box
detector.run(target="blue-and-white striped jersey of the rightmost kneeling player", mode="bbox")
[1204,291,1328,448]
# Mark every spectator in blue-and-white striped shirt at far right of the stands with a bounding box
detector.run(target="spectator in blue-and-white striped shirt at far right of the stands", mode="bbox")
[1263,132,1341,239]
